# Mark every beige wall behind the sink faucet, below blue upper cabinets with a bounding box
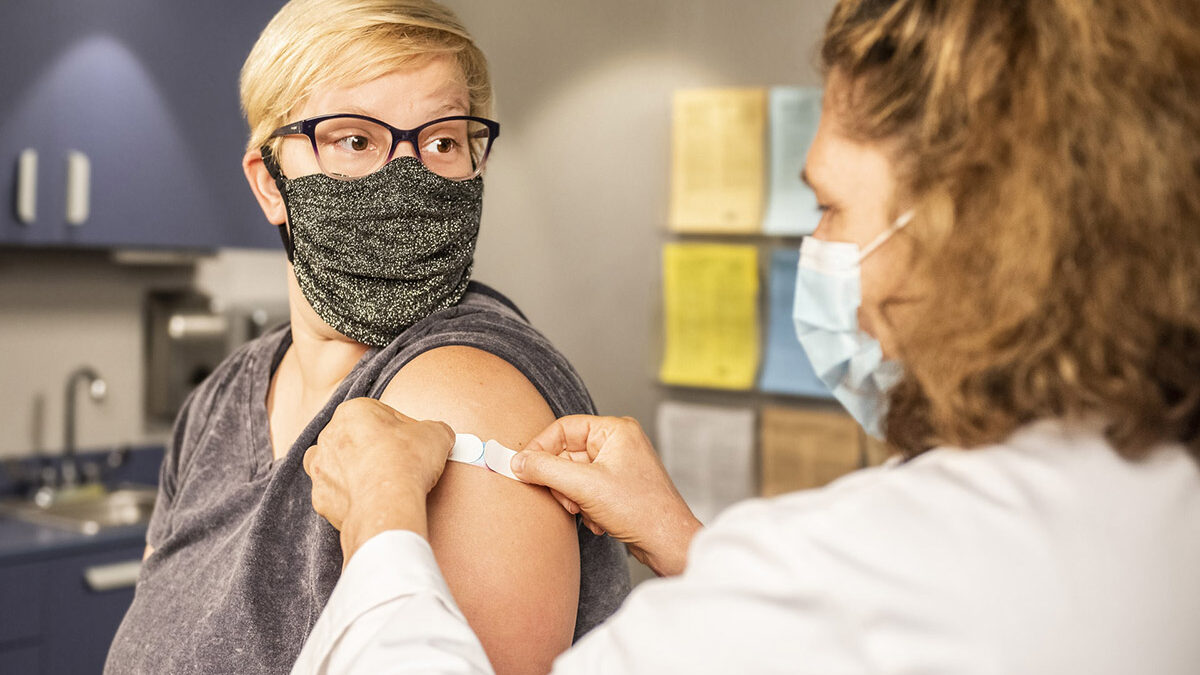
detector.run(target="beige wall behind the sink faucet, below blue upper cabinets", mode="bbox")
[0,248,284,456]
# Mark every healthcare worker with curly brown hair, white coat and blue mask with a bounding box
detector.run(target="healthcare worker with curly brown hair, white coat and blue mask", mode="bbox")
[296,0,1200,675]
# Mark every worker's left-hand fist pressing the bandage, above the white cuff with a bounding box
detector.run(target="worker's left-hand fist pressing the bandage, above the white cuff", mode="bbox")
[304,399,455,561]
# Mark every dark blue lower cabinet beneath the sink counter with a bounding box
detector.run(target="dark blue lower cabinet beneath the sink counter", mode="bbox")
[0,539,143,675]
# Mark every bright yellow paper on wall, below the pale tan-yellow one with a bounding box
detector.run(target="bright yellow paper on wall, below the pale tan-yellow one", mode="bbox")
[659,244,758,389]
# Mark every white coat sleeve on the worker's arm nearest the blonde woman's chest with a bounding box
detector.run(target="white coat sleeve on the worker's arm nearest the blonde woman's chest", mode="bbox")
[292,531,493,675]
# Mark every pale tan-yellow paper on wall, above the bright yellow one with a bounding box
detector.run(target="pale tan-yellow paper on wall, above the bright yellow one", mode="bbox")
[670,89,767,233]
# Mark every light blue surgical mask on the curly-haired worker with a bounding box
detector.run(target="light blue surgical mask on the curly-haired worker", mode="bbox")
[792,211,912,438]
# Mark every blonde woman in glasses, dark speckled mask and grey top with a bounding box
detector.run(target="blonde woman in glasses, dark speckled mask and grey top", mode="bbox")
[106,0,629,674]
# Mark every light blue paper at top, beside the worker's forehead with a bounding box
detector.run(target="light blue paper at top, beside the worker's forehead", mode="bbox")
[762,86,821,235]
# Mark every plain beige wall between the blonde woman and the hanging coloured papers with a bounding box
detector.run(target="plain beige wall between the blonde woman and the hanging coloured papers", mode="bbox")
[445,0,834,439]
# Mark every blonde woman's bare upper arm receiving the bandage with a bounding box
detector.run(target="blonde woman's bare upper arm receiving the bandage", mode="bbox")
[382,347,580,674]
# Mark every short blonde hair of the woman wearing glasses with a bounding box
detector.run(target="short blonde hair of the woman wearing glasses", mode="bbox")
[241,0,492,150]
